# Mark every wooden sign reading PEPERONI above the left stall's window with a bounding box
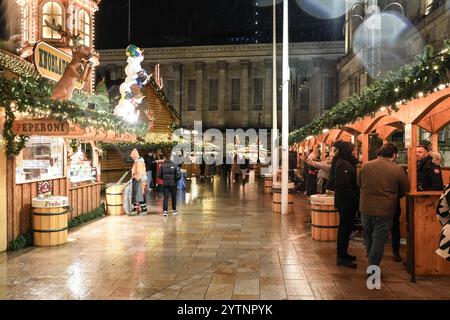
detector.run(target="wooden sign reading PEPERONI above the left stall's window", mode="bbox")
[12,119,69,136]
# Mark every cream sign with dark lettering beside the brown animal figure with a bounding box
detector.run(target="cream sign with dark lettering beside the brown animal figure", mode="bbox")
[34,42,83,90]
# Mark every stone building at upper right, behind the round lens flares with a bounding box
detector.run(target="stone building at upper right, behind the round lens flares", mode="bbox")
[337,0,450,100]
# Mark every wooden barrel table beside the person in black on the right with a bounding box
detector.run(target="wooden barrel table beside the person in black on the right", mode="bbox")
[309,194,339,241]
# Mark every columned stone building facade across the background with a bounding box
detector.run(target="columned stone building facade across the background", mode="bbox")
[97,41,344,129]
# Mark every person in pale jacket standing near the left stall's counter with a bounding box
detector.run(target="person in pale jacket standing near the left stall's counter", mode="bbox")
[130,149,147,215]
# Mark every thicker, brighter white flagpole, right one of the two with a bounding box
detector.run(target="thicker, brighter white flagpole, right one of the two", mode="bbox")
[281,0,290,214]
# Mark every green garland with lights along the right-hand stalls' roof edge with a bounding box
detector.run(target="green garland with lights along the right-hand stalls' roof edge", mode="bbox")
[289,41,450,145]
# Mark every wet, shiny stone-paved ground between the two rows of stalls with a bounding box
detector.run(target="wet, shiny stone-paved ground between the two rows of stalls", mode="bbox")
[0,175,450,300]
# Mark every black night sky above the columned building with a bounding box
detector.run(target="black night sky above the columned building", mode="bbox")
[96,0,343,49]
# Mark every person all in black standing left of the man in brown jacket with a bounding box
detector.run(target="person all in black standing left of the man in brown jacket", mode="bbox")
[334,142,359,268]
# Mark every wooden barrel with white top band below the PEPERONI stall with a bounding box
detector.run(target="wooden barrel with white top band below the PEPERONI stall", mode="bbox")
[31,197,69,247]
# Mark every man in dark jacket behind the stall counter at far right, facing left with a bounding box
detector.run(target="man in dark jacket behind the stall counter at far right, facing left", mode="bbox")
[416,144,444,191]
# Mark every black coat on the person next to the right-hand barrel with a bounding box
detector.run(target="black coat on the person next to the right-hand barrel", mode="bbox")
[334,159,359,212]
